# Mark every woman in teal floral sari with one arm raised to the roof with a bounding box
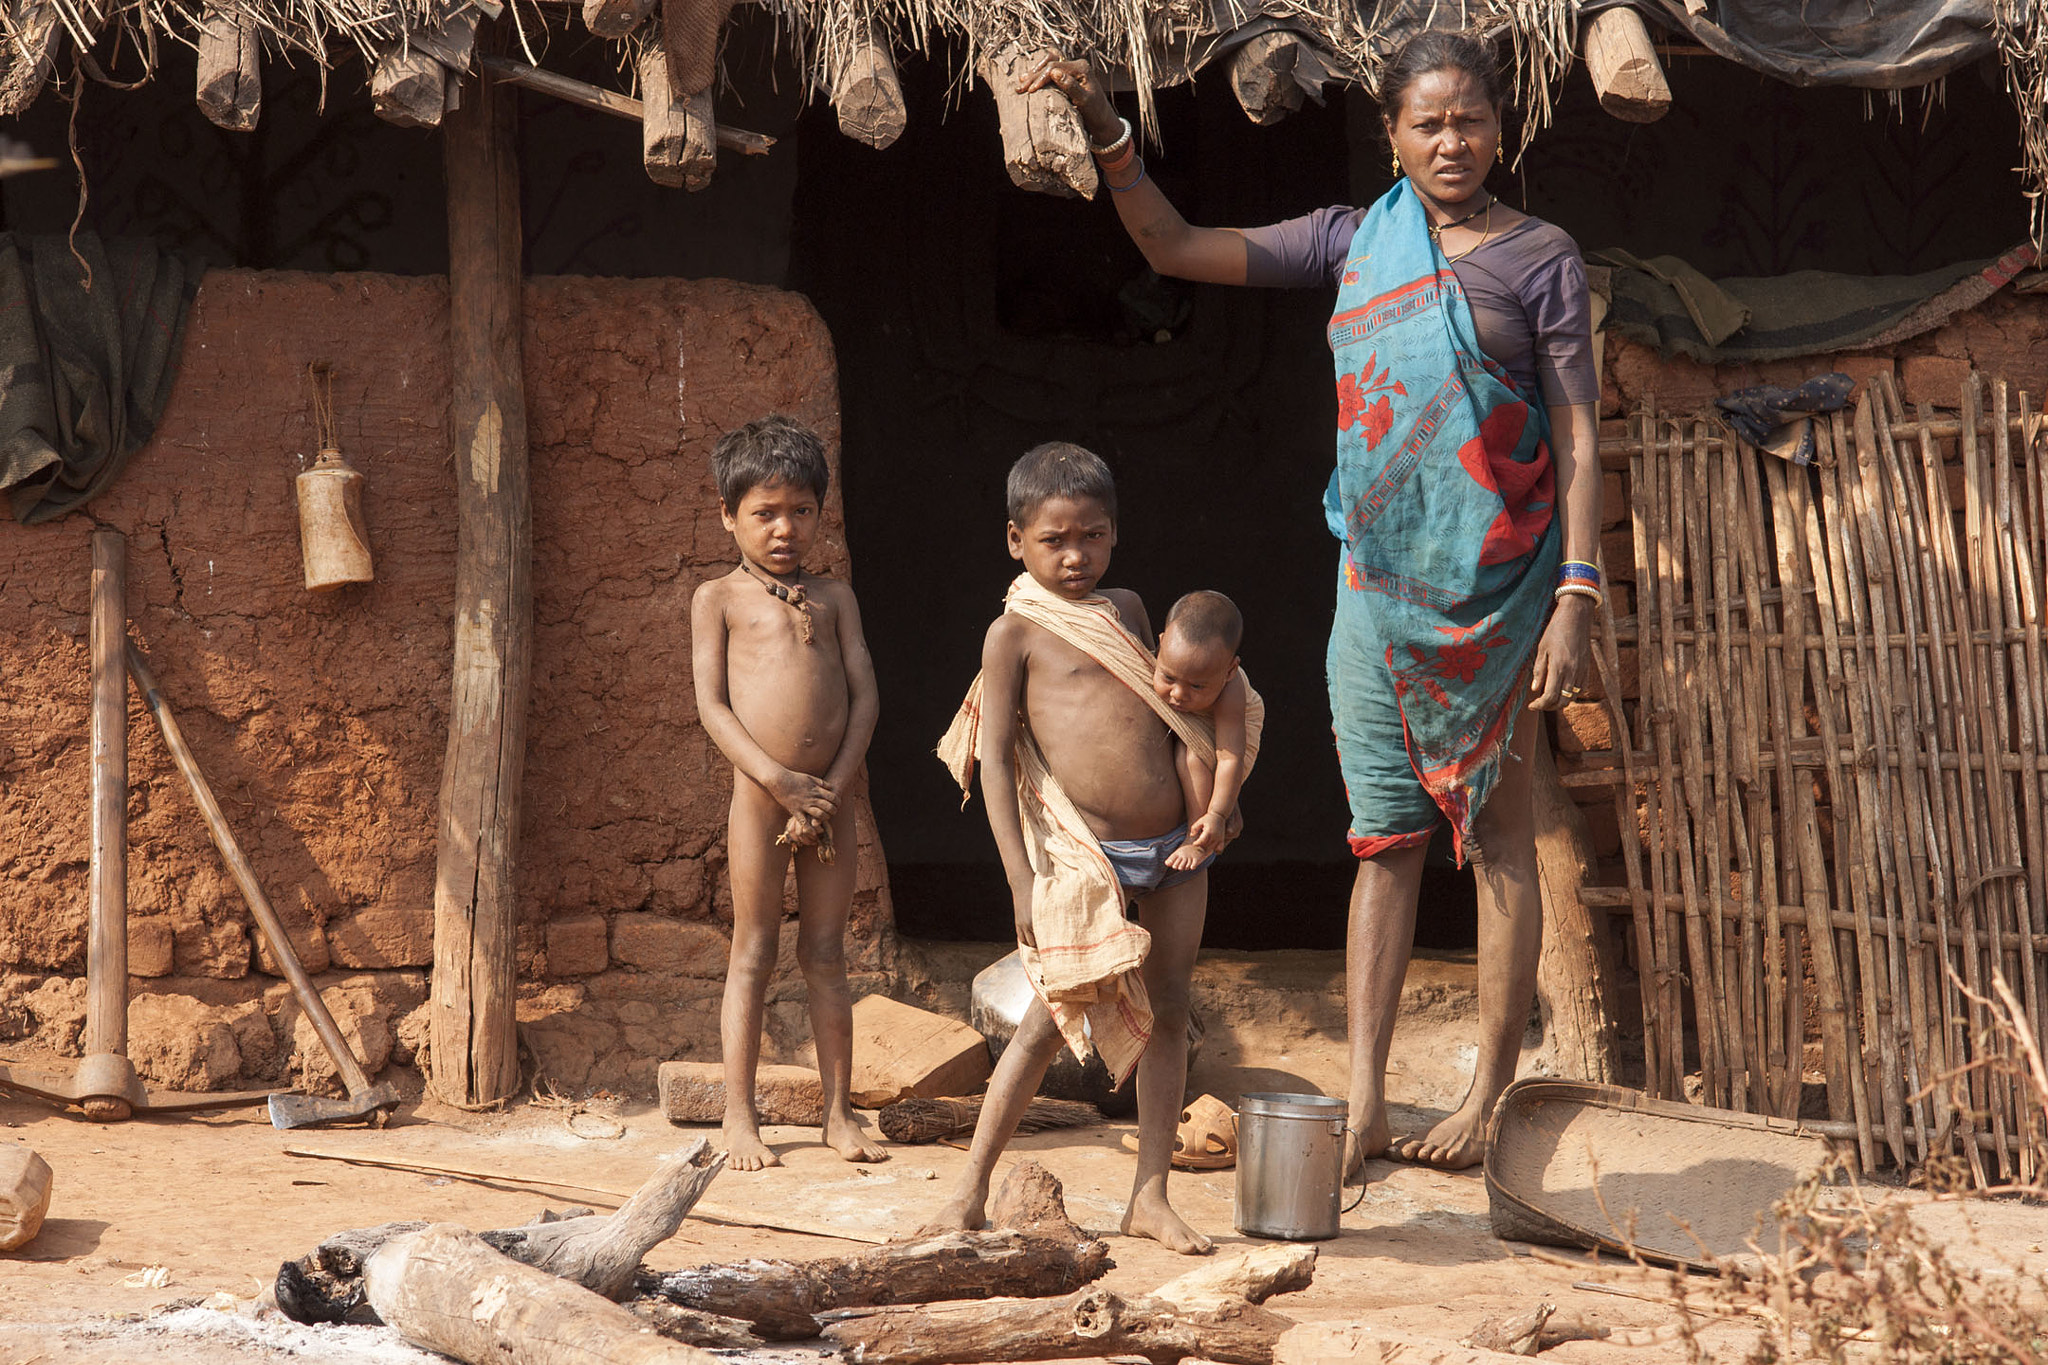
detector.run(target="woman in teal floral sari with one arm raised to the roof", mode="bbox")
[1026,33,1602,1175]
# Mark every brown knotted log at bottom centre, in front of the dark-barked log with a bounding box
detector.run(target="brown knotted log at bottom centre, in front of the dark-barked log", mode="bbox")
[823,1289,1294,1365]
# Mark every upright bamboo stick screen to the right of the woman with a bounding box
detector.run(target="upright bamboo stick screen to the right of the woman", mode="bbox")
[1579,375,2048,1183]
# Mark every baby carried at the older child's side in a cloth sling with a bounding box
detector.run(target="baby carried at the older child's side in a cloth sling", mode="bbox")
[1153,591,1247,872]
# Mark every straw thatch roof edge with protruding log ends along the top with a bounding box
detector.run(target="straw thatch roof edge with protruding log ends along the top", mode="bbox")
[0,0,2048,239]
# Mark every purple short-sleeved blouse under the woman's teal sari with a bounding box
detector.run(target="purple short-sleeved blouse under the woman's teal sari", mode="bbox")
[1243,205,1599,407]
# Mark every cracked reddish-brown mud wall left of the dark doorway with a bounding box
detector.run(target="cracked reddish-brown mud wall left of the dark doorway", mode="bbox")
[0,270,891,1087]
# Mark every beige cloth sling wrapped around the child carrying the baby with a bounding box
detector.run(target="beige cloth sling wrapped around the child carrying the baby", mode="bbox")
[938,573,1266,1085]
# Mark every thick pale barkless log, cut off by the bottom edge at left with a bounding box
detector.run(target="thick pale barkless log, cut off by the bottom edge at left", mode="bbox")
[362,1224,719,1365]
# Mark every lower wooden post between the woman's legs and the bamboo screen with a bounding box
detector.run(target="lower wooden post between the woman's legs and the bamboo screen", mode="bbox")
[1530,716,1632,1083]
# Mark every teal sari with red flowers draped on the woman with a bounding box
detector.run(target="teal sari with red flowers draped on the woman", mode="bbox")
[1323,180,1561,857]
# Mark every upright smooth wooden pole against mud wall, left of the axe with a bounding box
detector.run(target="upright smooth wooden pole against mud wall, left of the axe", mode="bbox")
[82,530,129,1124]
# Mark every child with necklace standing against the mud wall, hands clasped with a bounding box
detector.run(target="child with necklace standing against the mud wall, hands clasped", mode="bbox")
[690,417,889,1171]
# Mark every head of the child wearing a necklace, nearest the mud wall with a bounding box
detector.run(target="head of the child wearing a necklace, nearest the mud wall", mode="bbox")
[711,413,831,575]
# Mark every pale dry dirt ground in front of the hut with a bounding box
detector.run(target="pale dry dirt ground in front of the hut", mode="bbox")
[0,948,2048,1365]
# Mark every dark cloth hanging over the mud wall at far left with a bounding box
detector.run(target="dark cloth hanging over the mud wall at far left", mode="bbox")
[0,233,199,522]
